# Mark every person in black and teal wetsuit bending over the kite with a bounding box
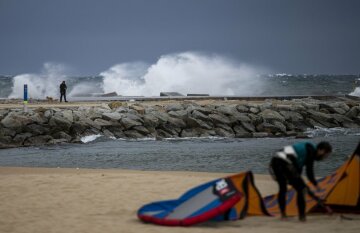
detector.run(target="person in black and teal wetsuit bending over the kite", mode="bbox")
[270,142,332,221]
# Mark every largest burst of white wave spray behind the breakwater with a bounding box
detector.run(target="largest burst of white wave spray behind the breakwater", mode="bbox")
[100,52,264,96]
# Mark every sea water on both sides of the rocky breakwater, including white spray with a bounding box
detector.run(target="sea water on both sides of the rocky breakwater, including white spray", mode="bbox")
[0,66,360,175]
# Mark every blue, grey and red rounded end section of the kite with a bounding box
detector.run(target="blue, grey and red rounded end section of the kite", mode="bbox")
[138,178,242,226]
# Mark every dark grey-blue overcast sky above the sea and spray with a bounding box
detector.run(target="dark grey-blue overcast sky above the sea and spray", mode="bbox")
[0,0,360,74]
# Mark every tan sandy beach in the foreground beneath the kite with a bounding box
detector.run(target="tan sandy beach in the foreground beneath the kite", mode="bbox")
[0,167,360,233]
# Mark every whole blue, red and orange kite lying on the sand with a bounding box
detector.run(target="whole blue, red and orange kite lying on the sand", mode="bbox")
[138,143,360,226]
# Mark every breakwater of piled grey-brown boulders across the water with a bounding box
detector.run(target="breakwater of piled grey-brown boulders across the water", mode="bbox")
[0,99,360,148]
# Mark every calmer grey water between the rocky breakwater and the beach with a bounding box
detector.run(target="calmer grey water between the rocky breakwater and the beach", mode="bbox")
[0,128,360,176]
